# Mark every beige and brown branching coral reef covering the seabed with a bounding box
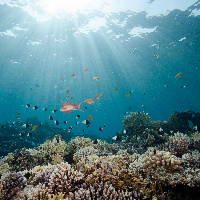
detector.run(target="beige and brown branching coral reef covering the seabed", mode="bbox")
[0,111,200,200]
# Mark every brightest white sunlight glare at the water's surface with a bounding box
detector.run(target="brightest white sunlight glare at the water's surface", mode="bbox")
[40,0,93,14]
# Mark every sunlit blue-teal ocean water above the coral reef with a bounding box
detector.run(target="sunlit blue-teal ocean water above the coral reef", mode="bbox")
[0,0,200,153]
